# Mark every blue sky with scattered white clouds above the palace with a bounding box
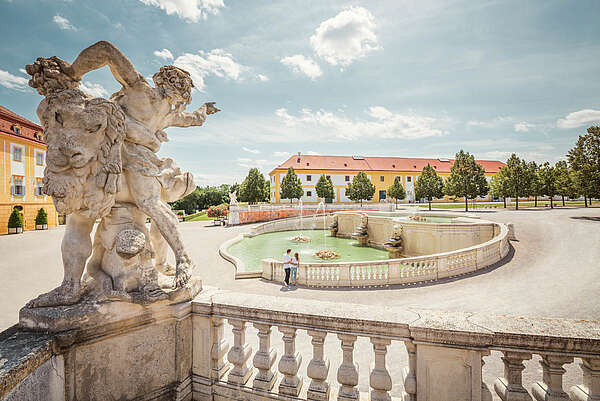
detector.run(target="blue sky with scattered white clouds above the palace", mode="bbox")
[0,0,600,186]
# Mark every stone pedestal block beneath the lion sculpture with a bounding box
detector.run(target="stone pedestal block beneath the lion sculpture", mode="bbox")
[19,280,200,401]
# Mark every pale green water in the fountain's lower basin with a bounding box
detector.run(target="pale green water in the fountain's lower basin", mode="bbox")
[228,230,388,272]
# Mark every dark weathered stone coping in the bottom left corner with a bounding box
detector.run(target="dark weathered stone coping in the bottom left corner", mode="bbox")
[0,326,54,399]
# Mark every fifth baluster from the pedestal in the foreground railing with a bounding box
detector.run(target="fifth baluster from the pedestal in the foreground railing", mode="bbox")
[306,330,329,401]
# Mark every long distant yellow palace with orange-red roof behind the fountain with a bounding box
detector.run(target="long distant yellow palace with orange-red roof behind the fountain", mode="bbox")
[269,153,505,204]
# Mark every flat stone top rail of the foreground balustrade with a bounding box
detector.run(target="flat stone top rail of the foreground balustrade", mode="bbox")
[192,289,600,357]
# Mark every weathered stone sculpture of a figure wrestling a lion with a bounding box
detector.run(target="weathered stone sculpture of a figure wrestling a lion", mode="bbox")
[26,41,219,309]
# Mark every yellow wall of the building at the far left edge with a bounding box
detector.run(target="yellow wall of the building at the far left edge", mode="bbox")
[0,134,58,234]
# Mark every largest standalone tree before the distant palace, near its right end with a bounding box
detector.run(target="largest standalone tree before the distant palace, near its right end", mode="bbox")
[444,149,488,211]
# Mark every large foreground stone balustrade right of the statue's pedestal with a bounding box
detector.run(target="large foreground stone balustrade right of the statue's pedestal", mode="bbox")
[192,289,600,401]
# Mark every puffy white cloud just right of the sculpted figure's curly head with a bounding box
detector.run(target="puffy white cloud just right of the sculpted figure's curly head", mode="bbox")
[173,49,248,90]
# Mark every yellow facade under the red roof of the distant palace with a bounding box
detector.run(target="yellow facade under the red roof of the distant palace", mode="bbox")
[269,169,494,204]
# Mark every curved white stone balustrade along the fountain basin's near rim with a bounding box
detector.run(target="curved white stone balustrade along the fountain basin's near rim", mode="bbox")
[262,224,509,287]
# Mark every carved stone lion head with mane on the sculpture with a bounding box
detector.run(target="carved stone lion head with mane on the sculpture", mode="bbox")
[38,89,125,218]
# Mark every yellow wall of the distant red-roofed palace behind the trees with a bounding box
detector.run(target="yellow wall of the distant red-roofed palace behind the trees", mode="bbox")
[269,170,494,204]
